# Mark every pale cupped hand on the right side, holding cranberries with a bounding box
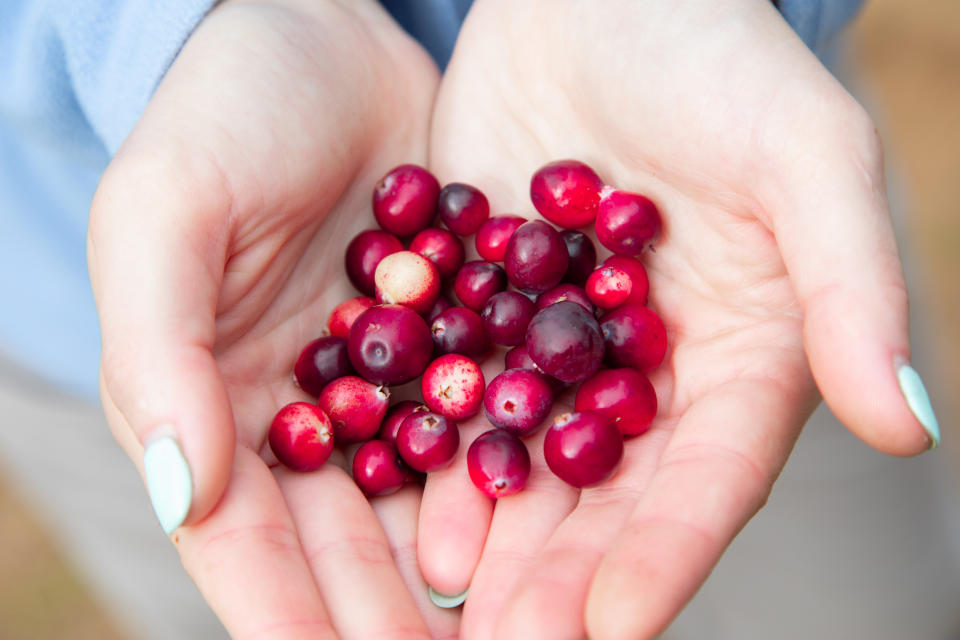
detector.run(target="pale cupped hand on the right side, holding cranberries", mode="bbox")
[419,0,930,640]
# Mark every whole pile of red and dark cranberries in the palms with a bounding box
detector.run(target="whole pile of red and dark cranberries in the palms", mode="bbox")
[269,160,667,498]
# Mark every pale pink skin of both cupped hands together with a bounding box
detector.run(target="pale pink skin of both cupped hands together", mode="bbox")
[90,0,929,639]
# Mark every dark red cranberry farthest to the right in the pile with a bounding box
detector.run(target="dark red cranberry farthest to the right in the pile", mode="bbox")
[600,304,667,373]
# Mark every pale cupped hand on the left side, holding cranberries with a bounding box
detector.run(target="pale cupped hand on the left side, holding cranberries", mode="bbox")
[89,0,458,638]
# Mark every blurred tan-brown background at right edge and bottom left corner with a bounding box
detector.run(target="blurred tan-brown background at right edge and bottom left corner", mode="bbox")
[0,0,960,640]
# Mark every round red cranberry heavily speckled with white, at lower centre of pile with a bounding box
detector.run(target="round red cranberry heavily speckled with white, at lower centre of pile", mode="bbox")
[420,353,484,421]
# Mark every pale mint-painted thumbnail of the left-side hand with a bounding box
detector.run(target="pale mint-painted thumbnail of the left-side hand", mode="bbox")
[143,436,193,535]
